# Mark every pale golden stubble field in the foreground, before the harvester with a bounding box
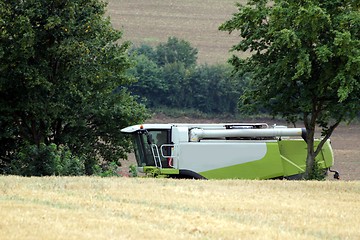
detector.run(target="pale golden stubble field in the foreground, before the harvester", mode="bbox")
[0,176,360,239]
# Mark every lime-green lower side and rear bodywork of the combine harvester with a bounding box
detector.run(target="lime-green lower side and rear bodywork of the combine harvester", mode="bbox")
[190,139,333,179]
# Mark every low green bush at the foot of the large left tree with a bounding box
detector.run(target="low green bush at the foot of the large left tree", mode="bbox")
[10,143,85,176]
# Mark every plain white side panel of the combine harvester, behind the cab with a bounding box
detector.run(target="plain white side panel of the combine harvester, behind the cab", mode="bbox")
[174,141,267,172]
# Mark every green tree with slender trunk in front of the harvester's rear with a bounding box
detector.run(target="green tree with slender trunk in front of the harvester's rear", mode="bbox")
[220,0,360,178]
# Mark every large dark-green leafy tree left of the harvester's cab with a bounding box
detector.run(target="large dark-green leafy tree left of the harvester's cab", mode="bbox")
[0,0,145,174]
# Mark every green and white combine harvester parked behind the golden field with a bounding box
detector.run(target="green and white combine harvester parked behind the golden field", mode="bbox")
[121,123,334,179]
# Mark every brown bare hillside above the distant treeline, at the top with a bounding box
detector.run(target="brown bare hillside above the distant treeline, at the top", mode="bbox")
[108,0,248,64]
